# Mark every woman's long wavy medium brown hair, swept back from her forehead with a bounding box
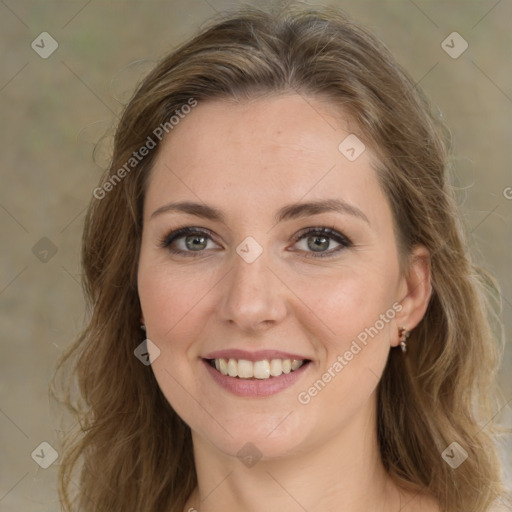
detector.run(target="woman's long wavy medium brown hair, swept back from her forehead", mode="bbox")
[54,8,510,512]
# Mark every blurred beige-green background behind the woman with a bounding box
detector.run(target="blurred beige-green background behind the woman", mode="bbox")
[0,0,512,512]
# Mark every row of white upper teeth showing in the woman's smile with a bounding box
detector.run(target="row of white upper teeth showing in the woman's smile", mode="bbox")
[214,359,304,379]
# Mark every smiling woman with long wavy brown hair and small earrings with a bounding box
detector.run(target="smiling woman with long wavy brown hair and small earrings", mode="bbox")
[54,5,510,512]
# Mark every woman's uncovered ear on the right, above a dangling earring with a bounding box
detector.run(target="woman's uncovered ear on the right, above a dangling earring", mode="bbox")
[392,245,432,346]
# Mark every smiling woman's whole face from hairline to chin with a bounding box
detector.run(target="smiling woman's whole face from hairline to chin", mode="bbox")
[138,95,420,457]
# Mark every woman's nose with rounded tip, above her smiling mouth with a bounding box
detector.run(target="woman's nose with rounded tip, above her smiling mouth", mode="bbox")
[218,247,287,332]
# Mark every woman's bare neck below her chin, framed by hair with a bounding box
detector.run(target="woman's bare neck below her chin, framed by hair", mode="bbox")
[185,400,401,512]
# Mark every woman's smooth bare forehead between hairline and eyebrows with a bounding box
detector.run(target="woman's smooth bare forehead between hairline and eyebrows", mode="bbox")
[146,95,384,226]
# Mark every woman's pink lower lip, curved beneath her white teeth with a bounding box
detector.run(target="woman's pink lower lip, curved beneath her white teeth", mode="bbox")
[203,359,311,397]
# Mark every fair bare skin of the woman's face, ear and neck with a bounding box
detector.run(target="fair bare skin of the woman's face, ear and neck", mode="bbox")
[138,94,438,512]
